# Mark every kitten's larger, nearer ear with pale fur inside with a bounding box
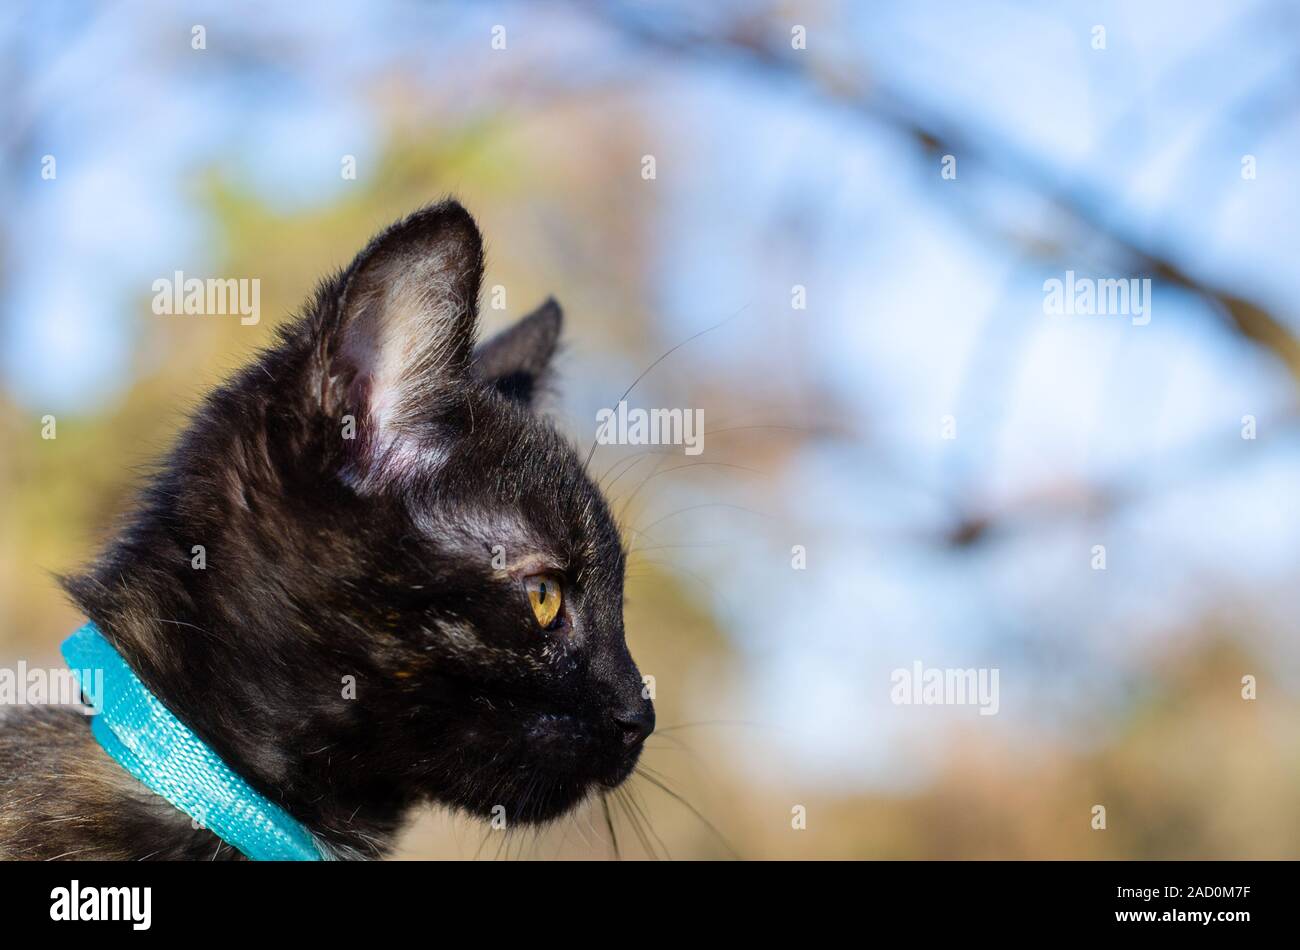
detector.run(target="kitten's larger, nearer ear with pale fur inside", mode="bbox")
[324,200,484,444]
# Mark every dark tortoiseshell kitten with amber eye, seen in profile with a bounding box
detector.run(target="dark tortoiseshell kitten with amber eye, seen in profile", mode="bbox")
[0,200,655,860]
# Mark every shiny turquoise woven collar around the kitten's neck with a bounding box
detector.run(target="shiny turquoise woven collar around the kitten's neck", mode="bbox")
[62,623,322,860]
